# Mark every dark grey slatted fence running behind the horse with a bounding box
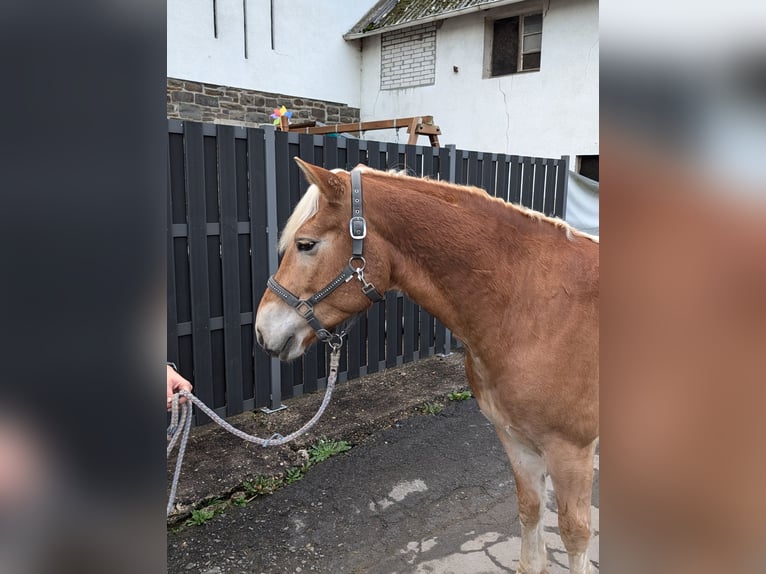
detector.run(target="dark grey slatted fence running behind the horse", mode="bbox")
[167,120,568,424]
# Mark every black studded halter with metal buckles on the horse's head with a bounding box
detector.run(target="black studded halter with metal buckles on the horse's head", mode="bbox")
[266,169,383,349]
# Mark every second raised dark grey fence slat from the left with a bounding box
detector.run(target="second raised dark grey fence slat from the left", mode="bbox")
[217,126,243,415]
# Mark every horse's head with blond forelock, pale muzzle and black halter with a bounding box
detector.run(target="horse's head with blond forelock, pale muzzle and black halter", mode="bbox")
[255,158,385,361]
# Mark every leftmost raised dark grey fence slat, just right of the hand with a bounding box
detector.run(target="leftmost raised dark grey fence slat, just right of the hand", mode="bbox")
[184,122,214,424]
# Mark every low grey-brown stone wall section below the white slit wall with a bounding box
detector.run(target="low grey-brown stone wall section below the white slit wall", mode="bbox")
[167,78,359,126]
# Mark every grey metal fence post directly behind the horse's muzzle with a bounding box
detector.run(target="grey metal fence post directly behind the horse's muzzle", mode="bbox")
[261,126,287,413]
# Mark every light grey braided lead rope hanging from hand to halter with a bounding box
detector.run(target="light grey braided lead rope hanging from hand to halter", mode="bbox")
[166,345,341,516]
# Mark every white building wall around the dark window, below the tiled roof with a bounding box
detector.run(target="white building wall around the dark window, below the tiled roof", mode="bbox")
[354,0,599,157]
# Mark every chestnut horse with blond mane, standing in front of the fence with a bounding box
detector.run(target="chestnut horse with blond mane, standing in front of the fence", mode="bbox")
[255,158,599,574]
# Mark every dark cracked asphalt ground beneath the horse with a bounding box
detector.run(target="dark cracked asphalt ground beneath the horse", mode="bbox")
[167,356,599,574]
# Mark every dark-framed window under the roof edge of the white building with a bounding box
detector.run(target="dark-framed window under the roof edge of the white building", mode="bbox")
[489,13,543,77]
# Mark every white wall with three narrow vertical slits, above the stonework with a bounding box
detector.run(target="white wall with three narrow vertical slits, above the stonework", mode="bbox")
[167,0,372,107]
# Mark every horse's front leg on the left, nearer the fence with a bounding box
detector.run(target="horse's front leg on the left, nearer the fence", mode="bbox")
[495,426,548,574]
